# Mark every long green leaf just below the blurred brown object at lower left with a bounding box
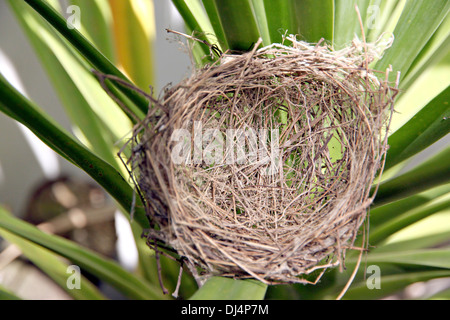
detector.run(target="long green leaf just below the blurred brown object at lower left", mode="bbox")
[0,208,163,299]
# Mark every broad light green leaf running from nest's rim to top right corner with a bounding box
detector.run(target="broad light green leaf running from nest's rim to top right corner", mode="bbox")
[375,0,450,81]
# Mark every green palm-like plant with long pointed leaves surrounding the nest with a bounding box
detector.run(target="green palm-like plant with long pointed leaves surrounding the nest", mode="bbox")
[0,0,450,299]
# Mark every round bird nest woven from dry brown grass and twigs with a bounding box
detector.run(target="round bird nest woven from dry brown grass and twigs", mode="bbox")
[122,37,397,283]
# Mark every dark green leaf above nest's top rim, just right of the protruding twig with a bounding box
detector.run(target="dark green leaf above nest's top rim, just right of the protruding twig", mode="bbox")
[214,0,260,52]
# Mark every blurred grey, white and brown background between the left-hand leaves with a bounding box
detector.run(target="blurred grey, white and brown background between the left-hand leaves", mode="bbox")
[0,0,192,299]
